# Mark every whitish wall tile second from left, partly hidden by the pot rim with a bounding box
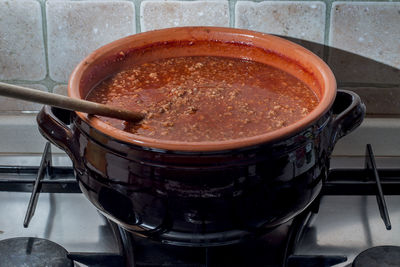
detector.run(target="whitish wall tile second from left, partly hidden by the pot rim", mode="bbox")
[46,1,136,82]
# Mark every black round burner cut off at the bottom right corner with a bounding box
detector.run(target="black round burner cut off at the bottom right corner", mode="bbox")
[352,246,400,267]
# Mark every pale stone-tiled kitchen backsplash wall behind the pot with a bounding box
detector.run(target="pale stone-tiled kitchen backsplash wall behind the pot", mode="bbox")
[0,0,400,155]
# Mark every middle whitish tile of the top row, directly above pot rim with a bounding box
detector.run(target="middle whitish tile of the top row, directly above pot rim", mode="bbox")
[140,0,229,31]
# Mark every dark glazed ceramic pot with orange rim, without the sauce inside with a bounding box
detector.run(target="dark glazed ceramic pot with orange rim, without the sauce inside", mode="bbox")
[37,27,365,246]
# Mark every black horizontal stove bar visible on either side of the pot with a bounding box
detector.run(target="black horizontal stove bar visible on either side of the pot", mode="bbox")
[0,169,400,196]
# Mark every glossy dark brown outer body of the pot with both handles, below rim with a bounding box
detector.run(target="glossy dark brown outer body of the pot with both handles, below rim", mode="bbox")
[38,91,365,246]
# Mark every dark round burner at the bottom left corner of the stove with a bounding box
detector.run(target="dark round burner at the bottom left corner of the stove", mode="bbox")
[0,237,74,267]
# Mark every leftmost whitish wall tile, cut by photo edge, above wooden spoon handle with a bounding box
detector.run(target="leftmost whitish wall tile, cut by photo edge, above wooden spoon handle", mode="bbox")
[0,0,46,81]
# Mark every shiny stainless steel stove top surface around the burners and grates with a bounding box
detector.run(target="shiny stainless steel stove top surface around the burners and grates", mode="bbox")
[0,146,400,267]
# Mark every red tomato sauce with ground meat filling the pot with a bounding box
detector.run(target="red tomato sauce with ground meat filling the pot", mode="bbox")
[87,56,318,142]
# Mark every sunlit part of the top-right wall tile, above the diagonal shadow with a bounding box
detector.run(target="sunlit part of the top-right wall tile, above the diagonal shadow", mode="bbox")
[329,2,400,68]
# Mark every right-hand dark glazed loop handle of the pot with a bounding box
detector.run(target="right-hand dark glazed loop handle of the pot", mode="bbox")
[331,90,366,148]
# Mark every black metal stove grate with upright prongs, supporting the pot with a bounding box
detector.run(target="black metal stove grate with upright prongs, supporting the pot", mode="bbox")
[0,143,400,267]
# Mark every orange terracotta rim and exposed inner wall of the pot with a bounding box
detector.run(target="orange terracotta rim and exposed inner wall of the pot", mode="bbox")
[68,27,336,151]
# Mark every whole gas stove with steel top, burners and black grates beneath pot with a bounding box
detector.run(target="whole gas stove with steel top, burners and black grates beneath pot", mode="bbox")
[0,141,400,267]
